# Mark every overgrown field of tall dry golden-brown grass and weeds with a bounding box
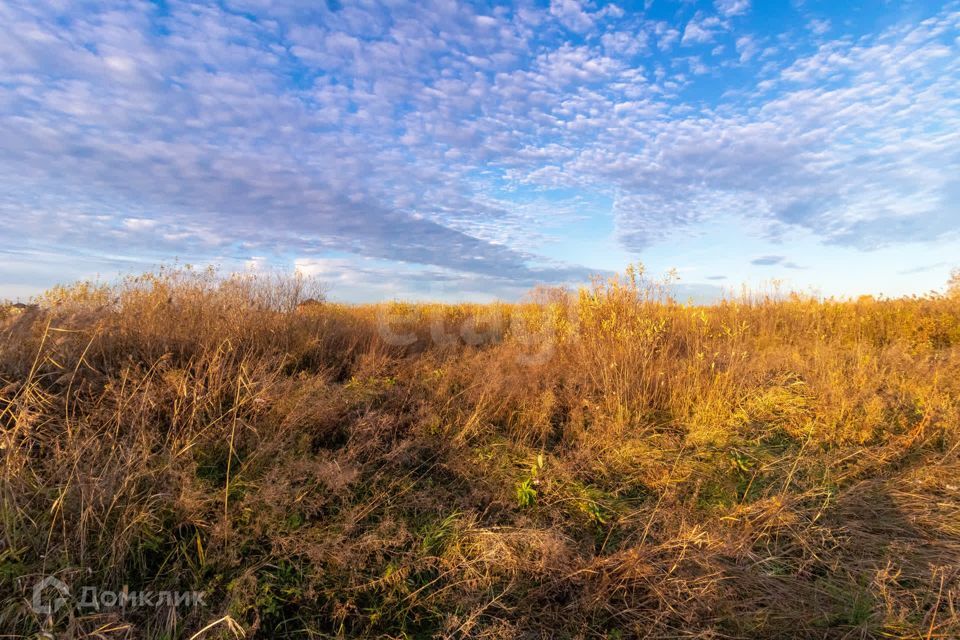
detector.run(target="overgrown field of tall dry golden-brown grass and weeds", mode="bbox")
[0,271,960,639]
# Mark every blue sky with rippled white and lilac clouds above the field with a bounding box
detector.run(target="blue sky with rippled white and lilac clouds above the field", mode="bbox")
[0,0,960,301]
